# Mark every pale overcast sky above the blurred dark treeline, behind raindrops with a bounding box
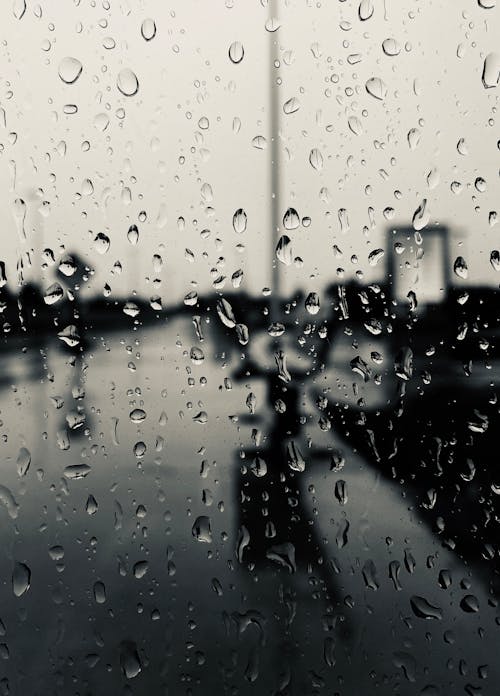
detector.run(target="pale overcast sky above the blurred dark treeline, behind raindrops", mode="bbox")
[0,0,500,305]
